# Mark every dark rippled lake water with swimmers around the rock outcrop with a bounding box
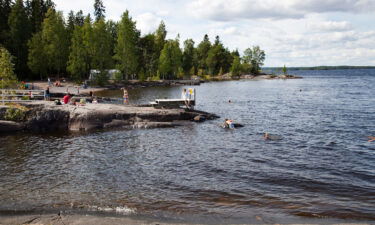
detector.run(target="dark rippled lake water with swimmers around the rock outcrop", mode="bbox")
[0,70,375,223]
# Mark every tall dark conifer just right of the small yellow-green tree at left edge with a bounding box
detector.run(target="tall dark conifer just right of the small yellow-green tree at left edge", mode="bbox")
[8,0,31,78]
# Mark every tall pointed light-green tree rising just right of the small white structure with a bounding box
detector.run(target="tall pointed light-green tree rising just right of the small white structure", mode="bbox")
[114,11,140,79]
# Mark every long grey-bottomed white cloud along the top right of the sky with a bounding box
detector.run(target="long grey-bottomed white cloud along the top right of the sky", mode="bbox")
[188,0,375,21]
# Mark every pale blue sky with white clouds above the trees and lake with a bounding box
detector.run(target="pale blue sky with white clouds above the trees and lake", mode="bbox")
[54,0,375,67]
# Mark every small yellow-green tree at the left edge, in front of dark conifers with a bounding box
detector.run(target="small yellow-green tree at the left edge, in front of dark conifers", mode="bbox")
[0,47,17,88]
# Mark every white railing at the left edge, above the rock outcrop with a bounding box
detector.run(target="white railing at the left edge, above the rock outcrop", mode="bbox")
[0,89,44,105]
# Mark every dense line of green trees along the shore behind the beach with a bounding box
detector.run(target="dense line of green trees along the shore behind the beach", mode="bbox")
[0,0,265,81]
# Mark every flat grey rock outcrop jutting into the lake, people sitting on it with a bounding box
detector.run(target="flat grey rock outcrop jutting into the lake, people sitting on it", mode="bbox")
[0,101,218,133]
